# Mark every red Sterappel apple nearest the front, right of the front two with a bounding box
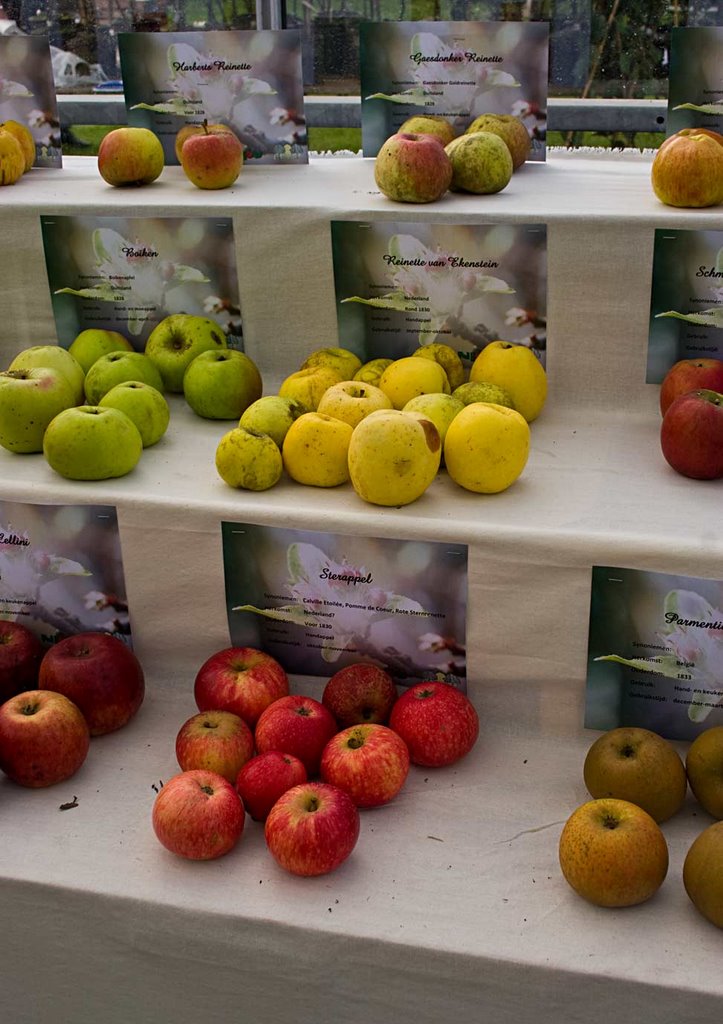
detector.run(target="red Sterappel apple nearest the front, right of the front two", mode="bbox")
[264,782,359,877]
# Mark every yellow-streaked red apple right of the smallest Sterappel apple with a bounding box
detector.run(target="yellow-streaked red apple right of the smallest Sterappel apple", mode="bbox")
[321,724,410,807]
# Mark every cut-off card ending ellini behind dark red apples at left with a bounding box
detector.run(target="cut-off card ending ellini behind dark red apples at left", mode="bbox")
[0,501,131,644]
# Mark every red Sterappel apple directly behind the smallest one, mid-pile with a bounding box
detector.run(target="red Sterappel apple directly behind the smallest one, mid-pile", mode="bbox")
[254,693,337,775]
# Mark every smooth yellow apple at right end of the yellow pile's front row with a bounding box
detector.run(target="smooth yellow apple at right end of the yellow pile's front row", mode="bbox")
[444,401,529,495]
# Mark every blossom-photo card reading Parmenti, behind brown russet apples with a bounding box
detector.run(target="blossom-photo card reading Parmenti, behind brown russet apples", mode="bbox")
[585,565,723,739]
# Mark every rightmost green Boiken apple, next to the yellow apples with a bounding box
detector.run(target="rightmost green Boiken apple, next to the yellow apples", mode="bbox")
[183,348,263,420]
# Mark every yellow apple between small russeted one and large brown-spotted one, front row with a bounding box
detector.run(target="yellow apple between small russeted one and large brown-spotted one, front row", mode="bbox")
[282,413,353,487]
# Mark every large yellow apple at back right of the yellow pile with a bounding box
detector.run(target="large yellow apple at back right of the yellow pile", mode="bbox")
[469,341,547,423]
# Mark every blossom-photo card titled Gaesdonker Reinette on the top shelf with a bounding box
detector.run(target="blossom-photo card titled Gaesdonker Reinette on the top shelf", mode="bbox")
[359,22,550,161]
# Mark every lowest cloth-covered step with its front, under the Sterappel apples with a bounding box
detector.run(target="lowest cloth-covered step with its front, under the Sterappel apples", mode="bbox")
[0,667,723,1024]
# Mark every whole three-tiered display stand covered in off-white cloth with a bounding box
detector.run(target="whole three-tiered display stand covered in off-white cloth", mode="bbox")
[0,154,723,1024]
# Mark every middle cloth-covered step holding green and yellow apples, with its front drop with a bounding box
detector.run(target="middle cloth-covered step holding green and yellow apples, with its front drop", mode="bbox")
[0,396,723,692]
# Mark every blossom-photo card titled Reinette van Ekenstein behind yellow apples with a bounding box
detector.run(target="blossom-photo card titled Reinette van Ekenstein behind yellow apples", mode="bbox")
[331,220,547,367]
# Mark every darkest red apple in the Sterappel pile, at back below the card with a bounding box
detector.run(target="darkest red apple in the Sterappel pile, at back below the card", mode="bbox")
[322,662,396,729]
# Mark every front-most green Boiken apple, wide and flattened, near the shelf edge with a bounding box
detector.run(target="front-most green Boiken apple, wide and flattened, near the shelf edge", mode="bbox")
[43,406,143,480]
